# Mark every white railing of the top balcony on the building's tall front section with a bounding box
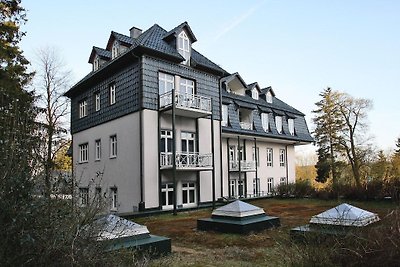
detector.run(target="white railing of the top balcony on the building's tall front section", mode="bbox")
[160,91,211,113]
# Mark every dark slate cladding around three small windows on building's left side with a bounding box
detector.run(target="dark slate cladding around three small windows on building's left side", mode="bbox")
[71,62,140,134]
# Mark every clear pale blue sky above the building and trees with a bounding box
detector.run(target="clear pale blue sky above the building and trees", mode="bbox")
[21,0,400,153]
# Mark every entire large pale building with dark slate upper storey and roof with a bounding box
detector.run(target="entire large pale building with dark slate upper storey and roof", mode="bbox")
[65,22,313,214]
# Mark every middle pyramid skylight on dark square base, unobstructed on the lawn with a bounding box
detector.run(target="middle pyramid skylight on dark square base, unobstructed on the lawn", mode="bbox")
[197,200,280,234]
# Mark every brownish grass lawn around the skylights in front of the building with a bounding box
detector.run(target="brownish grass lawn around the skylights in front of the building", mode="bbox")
[134,199,395,266]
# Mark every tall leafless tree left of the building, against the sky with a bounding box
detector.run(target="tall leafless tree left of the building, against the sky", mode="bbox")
[34,47,71,197]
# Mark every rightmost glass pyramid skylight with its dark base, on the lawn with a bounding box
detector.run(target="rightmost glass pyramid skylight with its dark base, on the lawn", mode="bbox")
[290,203,380,240]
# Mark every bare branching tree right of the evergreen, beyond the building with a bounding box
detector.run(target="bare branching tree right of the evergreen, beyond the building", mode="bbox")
[338,93,372,187]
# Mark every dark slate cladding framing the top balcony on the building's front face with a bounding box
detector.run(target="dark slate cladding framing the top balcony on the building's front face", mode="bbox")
[142,56,220,120]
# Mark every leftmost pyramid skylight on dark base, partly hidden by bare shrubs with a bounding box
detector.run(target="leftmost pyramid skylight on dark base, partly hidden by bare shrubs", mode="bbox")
[96,214,171,255]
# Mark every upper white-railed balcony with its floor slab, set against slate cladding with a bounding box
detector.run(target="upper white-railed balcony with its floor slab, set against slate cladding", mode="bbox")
[160,91,211,118]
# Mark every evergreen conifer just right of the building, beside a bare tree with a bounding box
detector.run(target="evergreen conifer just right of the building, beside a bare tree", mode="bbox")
[313,87,343,187]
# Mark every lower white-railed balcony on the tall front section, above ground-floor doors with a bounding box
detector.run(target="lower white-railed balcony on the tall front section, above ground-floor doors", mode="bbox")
[160,152,212,170]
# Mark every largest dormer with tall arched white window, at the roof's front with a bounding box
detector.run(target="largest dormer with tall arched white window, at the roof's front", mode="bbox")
[163,21,197,65]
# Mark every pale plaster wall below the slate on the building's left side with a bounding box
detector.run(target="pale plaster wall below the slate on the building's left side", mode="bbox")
[73,112,140,213]
